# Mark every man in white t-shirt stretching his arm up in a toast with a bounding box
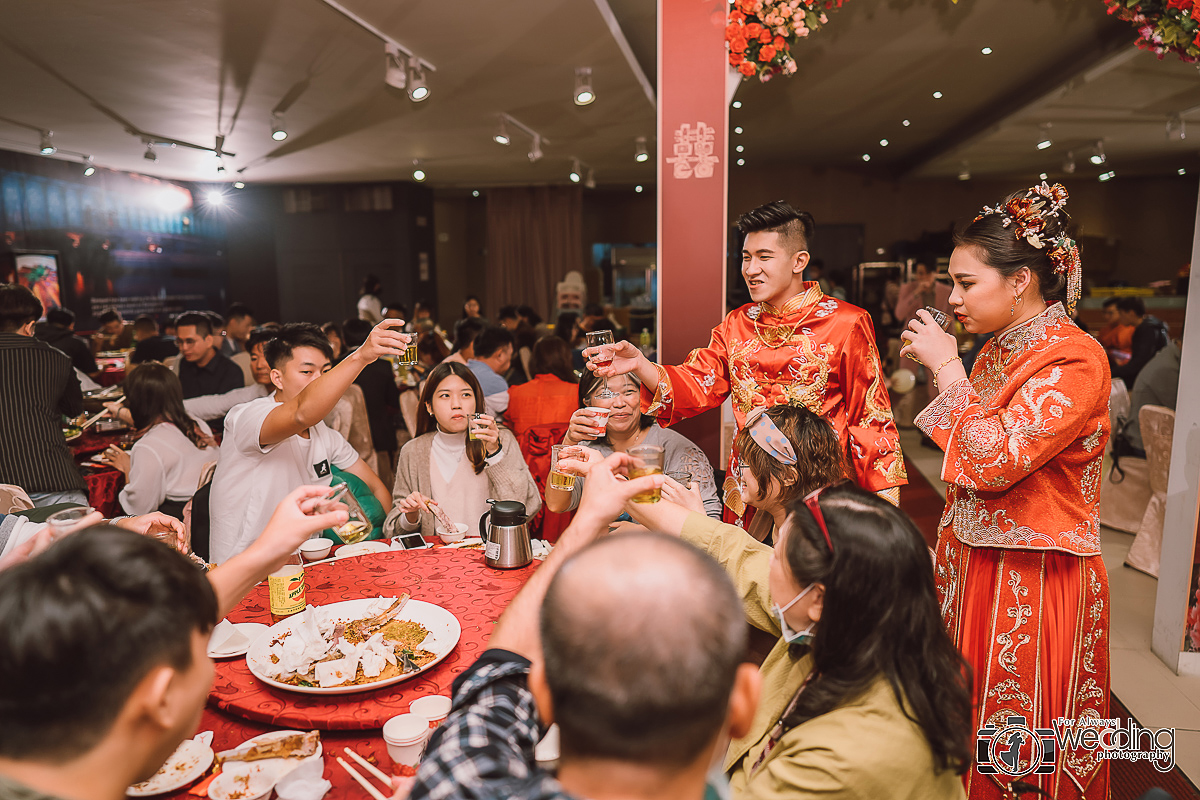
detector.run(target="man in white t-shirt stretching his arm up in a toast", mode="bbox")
[209,319,410,564]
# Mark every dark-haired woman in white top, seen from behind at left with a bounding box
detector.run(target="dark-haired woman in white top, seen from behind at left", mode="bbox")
[102,361,217,518]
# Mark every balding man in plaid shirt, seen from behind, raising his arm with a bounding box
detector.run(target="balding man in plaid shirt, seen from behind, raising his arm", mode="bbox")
[410,453,758,800]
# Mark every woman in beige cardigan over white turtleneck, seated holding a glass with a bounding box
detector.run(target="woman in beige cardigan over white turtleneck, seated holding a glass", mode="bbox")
[383,361,541,536]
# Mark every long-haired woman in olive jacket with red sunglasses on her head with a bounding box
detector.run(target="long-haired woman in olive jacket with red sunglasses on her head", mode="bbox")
[629,409,973,800]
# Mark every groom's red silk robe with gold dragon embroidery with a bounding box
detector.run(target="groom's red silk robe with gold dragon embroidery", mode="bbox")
[642,282,907,516]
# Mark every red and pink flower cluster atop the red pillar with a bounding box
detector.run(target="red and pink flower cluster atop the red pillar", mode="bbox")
[725,0,844,83]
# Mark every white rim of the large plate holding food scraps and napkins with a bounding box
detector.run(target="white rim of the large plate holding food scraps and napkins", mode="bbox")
[246,597,462,694]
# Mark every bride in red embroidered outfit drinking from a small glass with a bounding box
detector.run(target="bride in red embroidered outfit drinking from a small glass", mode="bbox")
[901,182,1110,800]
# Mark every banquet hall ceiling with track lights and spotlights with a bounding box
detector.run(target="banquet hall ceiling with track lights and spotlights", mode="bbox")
[0,0,1200,187]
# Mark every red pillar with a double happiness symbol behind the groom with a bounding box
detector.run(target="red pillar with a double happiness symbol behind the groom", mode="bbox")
[658,0,730,469]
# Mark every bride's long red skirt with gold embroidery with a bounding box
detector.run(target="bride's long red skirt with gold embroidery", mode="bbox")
[936,528,1109,800]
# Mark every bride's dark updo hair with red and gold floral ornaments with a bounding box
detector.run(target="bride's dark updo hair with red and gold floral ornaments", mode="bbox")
[954,184,1074,305]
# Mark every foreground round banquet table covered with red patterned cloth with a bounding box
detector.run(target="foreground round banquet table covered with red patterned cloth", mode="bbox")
[164,548,541,800]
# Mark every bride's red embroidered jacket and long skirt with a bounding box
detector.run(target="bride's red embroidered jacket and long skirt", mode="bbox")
[917,303,1111,800]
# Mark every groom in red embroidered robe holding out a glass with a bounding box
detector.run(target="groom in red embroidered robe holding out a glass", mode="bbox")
[587,200,907,518]
